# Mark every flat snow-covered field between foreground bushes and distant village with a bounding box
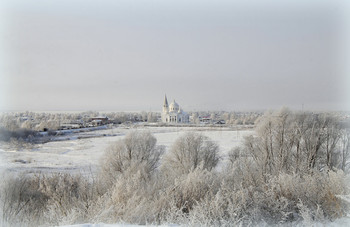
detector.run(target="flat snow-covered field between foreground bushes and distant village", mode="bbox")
[0,126,253,172]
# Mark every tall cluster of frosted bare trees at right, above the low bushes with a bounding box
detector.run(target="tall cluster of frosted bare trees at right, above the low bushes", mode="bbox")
[236,108,350,174]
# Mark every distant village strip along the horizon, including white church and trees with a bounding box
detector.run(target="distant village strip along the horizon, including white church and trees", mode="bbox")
[0,95,350,134]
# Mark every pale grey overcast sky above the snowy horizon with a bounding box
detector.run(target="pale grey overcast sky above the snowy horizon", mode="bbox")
[0,0,350,111]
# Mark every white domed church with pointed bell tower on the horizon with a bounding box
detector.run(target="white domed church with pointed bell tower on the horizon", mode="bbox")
[162,95,190,124]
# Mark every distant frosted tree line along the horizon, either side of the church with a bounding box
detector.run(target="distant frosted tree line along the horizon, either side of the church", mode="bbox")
[0,111,261,132]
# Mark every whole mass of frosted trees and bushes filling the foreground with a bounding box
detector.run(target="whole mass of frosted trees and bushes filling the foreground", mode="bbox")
[0,109,350,226]
